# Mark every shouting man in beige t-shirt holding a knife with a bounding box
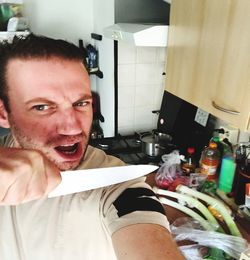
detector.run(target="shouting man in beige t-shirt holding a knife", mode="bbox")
[0,34,183,260]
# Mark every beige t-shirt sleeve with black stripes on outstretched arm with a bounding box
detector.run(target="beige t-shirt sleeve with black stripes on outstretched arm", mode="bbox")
[100,177,169,235]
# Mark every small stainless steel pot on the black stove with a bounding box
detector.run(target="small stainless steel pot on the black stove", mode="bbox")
[140,133,171,156]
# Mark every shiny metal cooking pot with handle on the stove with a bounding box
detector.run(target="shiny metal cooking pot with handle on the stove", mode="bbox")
[140,132,172,156]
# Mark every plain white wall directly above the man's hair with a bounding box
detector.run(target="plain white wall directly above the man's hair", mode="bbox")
[23,0,94,44]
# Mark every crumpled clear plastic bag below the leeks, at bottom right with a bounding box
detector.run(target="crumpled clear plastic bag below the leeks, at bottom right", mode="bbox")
[170,217,248,259]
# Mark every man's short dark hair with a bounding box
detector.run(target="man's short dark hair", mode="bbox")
[0,33,86,112]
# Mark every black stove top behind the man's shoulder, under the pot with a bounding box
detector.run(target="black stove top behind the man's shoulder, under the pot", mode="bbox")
[90,133,175,166]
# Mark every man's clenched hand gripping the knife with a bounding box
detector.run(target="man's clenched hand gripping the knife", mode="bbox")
[0,148,61,205]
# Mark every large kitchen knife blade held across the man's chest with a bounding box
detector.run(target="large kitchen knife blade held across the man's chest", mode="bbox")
[48,164,158,198]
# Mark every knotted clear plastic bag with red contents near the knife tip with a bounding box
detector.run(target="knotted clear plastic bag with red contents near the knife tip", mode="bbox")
[155,150,187,190]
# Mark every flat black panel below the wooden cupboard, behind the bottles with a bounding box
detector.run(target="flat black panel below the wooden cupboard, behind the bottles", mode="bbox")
[157,91,216,162]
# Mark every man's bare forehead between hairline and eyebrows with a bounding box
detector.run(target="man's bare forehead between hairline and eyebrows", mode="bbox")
[6,57,90,100]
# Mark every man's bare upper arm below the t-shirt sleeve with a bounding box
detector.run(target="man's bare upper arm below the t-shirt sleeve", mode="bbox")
[112,224,185,260]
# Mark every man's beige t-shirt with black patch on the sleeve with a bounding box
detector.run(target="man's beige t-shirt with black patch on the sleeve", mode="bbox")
[0,137,169,260]
